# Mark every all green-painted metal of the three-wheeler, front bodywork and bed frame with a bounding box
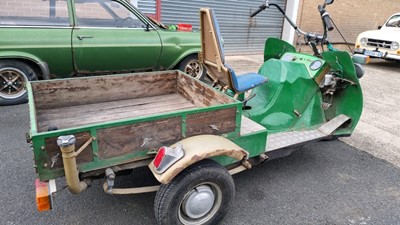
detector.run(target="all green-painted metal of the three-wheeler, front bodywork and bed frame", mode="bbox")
[28,37,362,184]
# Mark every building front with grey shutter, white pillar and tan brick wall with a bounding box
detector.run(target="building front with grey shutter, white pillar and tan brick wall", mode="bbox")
[139,0,400,54]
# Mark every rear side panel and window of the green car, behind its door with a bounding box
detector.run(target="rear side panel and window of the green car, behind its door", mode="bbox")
[0,0,73,77]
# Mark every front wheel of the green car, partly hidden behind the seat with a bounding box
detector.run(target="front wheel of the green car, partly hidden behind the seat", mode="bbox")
[178,55,206,80]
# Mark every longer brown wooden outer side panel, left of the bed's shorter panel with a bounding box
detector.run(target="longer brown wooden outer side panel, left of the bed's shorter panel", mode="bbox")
[97,117,182,159]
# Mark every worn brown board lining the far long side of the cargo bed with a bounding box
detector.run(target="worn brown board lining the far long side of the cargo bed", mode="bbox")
[32,71,177,109]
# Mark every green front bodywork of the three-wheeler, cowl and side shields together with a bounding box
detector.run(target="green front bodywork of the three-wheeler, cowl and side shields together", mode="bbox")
[244,38,363,135]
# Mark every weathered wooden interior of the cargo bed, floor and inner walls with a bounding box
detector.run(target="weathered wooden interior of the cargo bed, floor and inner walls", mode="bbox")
[32,71,238,132]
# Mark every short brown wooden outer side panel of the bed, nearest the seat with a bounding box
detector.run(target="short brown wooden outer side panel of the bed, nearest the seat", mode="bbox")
[186,107,236,137]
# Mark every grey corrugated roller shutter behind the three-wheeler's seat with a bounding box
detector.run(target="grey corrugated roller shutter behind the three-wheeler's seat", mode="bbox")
[161,0,286,54]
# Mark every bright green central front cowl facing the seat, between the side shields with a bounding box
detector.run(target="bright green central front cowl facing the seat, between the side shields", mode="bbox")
[246,59,324,133]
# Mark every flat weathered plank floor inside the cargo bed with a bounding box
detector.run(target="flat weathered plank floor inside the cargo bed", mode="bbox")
[36,94,196,132]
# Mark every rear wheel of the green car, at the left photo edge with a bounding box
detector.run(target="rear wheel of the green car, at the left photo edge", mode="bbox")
[0,60,37,105]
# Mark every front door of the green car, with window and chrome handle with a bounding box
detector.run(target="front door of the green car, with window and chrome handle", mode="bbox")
[72,0,161,74]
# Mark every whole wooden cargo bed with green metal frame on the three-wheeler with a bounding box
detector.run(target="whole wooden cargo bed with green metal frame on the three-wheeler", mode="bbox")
[28,71,242,180]
